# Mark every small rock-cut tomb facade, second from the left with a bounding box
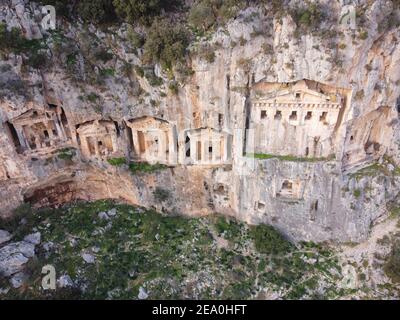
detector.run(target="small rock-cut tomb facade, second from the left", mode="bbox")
[77,120,118,159]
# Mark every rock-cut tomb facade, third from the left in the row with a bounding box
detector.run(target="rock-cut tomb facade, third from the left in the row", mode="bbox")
[126,116,178,165]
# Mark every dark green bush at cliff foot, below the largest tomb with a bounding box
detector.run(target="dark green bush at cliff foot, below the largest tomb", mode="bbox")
[250,224,293,255]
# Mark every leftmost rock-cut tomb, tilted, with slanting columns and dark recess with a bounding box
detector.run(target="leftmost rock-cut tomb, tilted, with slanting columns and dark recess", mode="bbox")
[6,108,70,154]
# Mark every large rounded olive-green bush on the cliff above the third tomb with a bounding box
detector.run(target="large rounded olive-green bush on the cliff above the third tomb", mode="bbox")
[143,18,189,70]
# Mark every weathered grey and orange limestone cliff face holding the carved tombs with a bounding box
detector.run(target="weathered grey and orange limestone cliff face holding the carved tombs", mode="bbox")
[0,1,400,241]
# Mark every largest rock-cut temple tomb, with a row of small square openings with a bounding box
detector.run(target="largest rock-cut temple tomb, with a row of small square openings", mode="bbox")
[246,80,343,157]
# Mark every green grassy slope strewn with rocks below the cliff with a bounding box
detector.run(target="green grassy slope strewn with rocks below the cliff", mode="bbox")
[0,201,345,299]
